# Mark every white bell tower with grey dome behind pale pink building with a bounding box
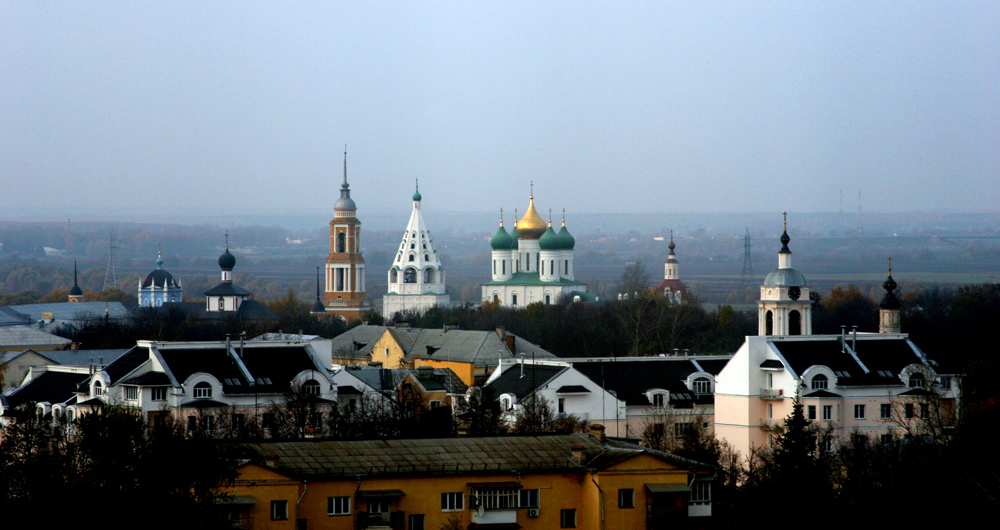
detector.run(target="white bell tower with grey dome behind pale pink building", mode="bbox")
[757,212,812,335]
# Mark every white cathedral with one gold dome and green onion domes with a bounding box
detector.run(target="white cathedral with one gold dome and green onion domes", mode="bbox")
[482,193,596,306]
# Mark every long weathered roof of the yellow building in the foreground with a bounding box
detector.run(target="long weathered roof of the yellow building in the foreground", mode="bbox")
[243,434,704,478]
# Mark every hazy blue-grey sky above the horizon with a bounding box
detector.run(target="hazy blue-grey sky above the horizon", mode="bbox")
[0,0,1000,219]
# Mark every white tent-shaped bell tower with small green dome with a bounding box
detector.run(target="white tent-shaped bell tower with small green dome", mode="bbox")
[382,186,451,318]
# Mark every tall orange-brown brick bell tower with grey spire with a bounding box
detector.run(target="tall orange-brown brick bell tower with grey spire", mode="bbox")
[323,151,372,322]
